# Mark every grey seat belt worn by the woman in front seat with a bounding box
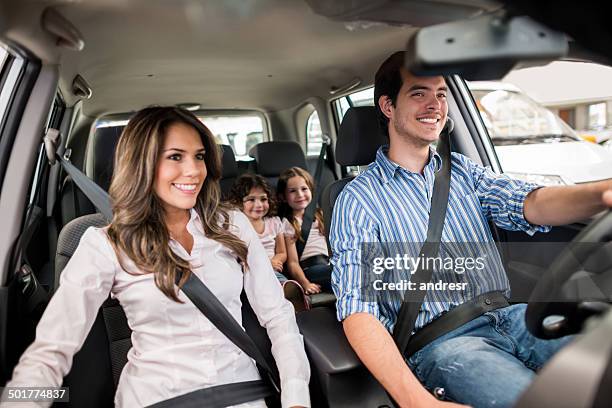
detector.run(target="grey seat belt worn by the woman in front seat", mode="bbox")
[52,128,280,407]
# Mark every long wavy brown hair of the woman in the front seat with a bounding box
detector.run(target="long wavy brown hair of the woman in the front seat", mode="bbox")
[108,106,247,302]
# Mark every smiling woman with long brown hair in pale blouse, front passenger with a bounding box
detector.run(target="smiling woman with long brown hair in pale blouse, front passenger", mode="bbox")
[2,107,310,407]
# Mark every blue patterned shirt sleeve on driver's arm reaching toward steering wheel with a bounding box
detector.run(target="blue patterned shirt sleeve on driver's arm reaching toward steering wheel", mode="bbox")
[460,154,551,235]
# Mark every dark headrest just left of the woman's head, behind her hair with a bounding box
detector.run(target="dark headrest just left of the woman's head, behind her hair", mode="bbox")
[85,126,124,191]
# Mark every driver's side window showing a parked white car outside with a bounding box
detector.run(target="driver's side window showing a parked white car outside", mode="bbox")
[468,61,612,185]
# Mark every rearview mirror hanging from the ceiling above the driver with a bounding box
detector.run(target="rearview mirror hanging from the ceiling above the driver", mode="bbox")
[406,15,568,80]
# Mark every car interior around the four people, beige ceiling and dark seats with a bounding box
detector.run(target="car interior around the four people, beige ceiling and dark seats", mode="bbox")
[0,0,612,407]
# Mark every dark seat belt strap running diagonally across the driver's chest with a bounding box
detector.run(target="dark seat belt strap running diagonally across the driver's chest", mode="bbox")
[393,118,454,355]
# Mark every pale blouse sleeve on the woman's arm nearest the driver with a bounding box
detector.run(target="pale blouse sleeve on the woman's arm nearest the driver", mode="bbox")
[233,212,310,407]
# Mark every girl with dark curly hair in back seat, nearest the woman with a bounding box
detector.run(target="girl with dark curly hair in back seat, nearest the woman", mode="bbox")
[229,174,309,312]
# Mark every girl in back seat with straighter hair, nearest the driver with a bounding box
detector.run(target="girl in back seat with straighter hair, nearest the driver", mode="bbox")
[276,167,331,294]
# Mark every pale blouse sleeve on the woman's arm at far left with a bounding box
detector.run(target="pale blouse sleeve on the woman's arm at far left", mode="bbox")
[6,228,117,407]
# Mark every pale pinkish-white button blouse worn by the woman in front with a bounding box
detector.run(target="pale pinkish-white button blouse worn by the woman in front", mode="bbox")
[6,210,310,408]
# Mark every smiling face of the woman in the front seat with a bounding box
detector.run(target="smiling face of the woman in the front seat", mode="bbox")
[153,123,206,213]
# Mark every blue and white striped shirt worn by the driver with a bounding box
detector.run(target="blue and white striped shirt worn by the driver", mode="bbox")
[330,146,550,332]
